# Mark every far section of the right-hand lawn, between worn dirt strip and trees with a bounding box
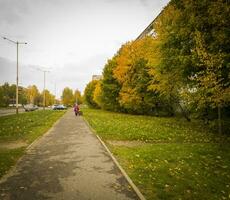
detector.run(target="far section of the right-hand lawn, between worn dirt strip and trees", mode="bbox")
[83,109,230,143]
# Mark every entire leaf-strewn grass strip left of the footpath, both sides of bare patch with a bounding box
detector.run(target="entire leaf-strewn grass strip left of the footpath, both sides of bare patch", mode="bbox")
[0,110,65,177]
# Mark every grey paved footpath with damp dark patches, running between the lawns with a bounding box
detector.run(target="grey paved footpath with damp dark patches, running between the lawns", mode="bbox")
[0,110,138,200]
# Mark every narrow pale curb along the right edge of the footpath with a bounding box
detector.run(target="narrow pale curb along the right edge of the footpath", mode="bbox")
[82,117,146,200]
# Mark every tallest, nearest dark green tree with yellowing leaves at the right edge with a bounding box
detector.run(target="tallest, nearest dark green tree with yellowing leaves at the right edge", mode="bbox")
[154,0,230,125]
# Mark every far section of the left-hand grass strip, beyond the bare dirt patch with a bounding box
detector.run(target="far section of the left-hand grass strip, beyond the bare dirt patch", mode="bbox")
[0,110,64,143]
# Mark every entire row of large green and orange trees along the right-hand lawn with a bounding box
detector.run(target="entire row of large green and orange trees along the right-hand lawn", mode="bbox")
[85,0,230,134]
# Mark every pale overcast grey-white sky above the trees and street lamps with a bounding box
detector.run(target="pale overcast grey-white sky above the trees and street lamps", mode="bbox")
[0,0,169,97]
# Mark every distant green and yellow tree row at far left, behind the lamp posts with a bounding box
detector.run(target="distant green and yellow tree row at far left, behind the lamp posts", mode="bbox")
[0,83,56,107]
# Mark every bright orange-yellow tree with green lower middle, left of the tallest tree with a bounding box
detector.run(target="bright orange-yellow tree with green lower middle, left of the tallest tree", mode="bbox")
[114,37,167,114]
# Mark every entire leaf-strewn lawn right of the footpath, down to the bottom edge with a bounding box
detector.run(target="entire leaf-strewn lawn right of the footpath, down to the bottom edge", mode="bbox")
[83,109,230,200]
